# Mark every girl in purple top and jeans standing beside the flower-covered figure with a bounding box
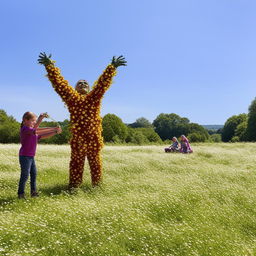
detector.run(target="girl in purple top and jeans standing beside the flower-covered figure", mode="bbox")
[18,112,61,198]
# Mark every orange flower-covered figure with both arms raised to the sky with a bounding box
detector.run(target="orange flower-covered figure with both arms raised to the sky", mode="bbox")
[38,53,126,187]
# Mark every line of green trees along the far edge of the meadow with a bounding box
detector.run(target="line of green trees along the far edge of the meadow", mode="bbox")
[0,98,256,145]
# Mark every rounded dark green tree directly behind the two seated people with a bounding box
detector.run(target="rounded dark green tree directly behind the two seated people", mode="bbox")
[153,113,189,140]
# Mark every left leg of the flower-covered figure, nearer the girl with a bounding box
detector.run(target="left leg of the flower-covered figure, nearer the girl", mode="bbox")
[69,143,86,188]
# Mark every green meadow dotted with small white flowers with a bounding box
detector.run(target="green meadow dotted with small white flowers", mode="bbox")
[0,143,256,256]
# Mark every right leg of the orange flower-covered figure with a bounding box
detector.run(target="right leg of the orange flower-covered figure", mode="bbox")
[87,149,102,186]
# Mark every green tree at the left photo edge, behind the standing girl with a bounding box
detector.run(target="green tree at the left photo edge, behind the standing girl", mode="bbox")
[0,109,20,143]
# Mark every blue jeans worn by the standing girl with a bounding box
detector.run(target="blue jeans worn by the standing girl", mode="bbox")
[18,156,37,195]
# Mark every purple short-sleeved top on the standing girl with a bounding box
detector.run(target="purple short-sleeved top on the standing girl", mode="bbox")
[19,126,41,156]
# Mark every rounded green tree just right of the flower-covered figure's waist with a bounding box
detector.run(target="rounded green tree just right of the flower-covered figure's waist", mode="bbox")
[102,114,128,142]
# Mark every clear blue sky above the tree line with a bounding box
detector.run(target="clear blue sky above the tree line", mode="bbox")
[0,0,256,124]
